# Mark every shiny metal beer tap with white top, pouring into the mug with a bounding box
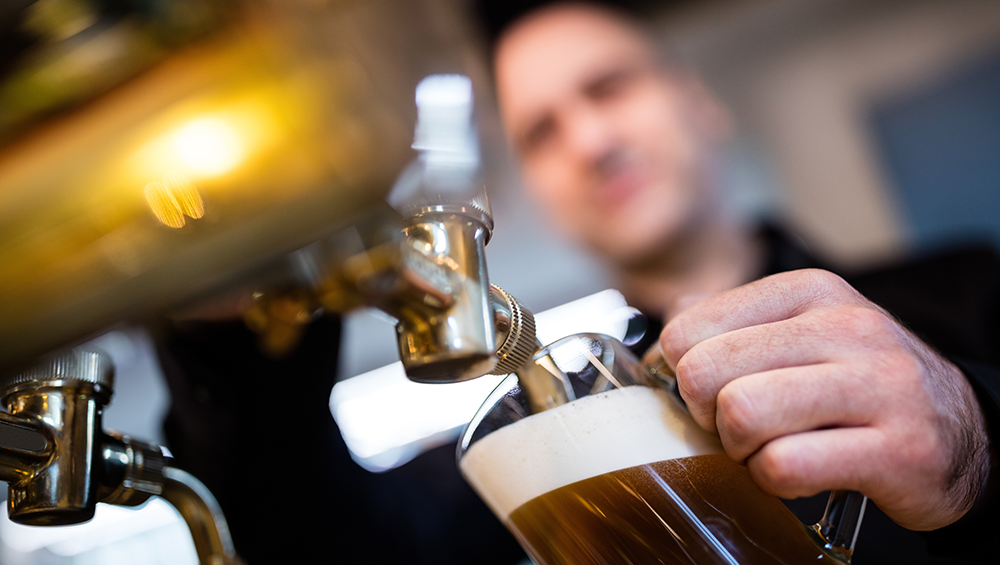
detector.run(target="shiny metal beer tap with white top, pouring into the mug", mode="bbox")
[286,75,537,383]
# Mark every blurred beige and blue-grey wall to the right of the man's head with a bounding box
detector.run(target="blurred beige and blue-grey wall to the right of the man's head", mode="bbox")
[662,0,1000,264]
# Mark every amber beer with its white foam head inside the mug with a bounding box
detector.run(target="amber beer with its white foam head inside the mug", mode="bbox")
[461,386,836,565]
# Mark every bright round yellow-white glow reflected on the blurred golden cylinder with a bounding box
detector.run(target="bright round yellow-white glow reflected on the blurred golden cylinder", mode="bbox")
[173,117,245,175]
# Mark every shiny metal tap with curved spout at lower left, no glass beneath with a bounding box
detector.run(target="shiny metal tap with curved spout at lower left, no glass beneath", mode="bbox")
[0,349,242,565]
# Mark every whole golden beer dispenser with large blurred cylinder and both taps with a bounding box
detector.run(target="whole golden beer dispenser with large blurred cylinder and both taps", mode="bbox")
[0,0,535,564]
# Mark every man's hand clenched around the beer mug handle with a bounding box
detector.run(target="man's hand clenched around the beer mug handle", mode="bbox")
[660,270,989,530]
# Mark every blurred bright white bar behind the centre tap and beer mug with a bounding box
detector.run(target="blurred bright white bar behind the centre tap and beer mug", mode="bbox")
[330,290,636,472]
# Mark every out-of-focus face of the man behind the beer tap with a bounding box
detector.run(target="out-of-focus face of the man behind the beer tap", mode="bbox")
[496,7,724,264]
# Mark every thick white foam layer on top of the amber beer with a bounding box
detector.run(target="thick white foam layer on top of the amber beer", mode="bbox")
[461,386,722,519]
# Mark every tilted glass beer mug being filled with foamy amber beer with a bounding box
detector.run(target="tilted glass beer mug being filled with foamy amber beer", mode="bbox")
[458,334,865,565]
